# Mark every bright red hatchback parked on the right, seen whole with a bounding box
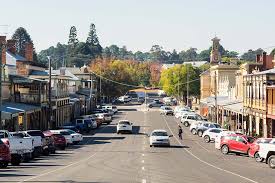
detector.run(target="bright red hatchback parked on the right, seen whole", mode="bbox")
[221,134,254,154]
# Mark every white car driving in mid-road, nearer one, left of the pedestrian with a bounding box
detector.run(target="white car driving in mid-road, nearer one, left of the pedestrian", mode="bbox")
[150,130,172,147]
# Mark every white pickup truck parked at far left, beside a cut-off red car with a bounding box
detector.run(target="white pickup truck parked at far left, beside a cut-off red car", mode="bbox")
[0,130,33,166]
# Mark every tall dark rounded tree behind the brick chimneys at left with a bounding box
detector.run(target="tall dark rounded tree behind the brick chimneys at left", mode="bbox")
[12,27,37,61]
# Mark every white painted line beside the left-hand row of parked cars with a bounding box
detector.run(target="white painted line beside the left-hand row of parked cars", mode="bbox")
[19,112,128,183]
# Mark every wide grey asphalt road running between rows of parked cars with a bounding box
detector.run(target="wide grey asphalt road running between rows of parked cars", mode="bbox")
[0,106,275,183]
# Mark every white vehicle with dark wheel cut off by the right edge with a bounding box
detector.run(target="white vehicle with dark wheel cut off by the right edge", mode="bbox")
[259,139,275,169]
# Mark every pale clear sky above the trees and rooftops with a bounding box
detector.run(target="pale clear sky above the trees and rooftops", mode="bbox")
[0,0,275,53]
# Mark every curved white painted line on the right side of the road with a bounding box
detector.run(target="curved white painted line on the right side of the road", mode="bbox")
[163,114,258,183]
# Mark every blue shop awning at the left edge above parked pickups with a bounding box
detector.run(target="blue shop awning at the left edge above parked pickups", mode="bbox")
[1,102,41,119]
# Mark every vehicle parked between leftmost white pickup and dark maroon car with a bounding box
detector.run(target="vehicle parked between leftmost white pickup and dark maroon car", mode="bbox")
[23,130,50,157]
